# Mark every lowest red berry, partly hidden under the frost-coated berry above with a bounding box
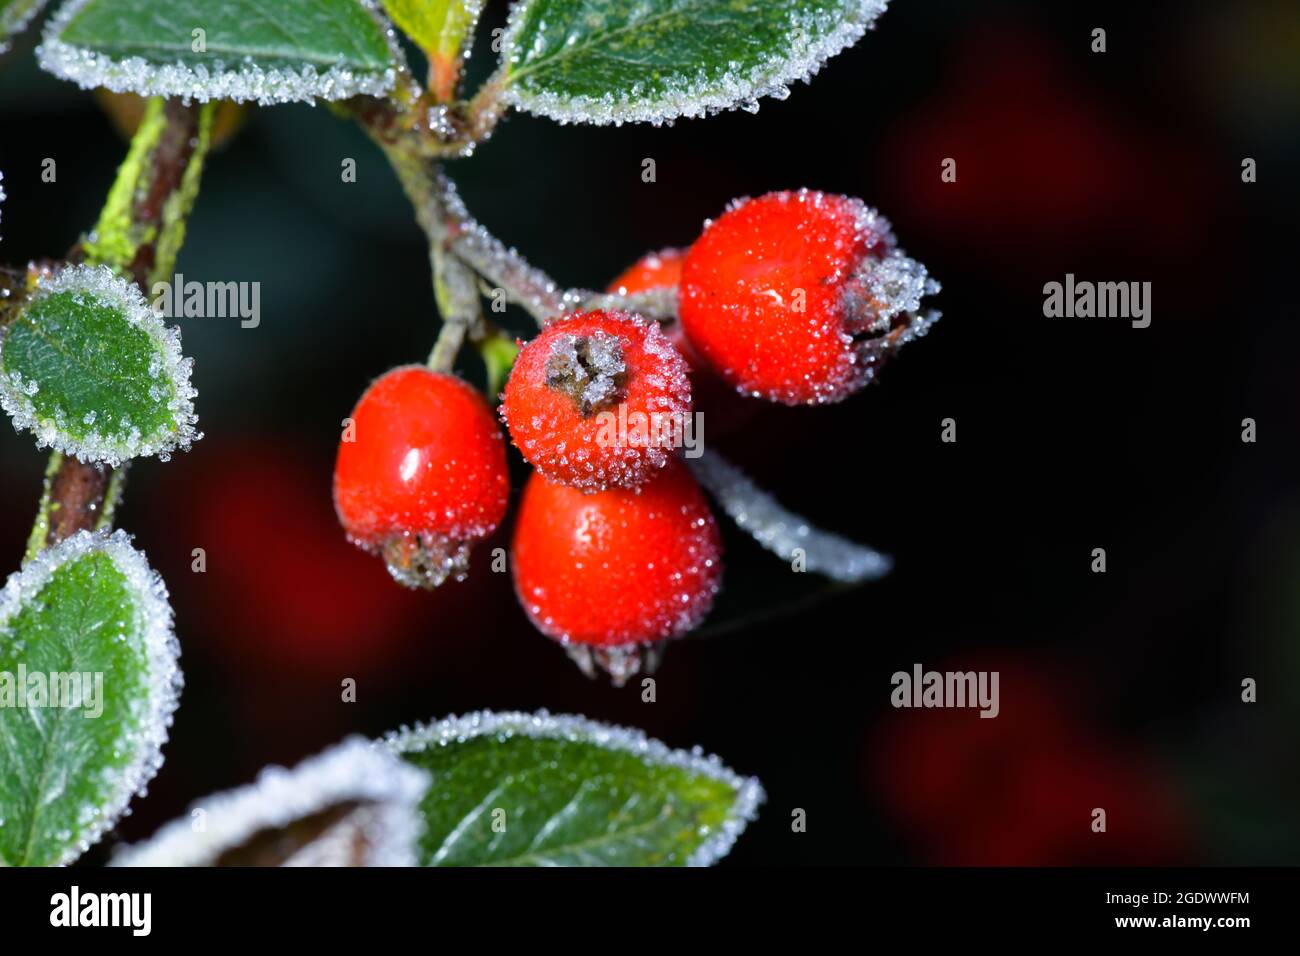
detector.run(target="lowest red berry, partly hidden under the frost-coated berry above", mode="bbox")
[511,459,722,683]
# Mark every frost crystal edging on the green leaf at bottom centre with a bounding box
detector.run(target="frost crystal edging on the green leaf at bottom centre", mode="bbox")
[380,710,766,866]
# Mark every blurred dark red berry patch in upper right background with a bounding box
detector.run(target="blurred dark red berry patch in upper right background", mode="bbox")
[876,27,1236,293]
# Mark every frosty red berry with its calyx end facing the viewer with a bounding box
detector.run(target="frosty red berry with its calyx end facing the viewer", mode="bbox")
[502,312,690,492]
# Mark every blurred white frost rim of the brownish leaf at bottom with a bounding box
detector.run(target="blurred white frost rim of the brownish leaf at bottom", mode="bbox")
[112,737,429,866]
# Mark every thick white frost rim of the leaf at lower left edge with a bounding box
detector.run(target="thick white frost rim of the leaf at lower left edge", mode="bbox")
[0,531,185,865]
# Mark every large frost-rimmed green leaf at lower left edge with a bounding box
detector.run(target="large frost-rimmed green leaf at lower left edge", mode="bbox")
[0,531,181,866]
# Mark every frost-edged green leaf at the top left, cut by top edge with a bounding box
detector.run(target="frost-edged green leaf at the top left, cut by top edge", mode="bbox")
[36,0,400,104]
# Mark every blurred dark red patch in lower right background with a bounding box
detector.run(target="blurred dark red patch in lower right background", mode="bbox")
[871,661,1191,866]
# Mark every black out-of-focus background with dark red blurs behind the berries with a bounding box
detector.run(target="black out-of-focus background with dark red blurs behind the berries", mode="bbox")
[0,0,1300,865]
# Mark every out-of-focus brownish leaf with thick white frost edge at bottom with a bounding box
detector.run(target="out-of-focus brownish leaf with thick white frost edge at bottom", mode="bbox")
[113,737,429,866]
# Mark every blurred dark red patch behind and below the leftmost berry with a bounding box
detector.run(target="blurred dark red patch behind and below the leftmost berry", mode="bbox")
[163,440,465,680]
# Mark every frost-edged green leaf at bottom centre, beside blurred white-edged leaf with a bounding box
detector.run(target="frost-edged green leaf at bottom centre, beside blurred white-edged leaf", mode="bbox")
[384,710,763,866]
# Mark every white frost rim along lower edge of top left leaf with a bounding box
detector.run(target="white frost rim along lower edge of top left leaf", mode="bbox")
[36,0,404,107]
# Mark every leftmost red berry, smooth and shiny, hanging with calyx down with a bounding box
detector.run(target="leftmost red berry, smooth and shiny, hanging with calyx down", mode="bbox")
[334,365,510,587]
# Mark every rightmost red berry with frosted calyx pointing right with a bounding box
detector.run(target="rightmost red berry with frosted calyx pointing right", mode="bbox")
[679,190,939,405]
